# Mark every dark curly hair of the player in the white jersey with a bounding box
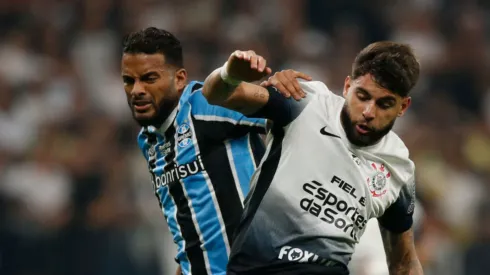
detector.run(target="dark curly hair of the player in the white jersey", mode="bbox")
[351,41,420,97]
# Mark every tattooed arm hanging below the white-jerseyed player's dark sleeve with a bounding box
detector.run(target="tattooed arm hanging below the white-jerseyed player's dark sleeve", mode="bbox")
[379,225,424,275]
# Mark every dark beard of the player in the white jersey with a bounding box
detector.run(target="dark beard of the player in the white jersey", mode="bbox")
[340,105,396,146]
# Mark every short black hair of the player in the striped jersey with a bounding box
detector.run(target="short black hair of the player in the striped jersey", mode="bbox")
[123,27,184,68]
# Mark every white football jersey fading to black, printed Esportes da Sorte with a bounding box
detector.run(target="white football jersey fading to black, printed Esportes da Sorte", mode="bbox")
[228,81,415,272]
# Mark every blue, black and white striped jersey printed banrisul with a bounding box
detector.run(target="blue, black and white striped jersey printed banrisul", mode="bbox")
[138,82,266,275]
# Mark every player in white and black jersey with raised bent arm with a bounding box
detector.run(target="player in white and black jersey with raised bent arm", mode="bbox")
[203,42,423,275]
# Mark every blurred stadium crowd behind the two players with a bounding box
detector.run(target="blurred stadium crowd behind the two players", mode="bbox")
[0,0,490,275]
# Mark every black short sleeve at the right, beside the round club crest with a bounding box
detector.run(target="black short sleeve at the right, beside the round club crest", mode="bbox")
[378,182,415,233]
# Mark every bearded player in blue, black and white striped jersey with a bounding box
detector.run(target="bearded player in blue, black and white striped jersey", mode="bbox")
[121,28,304,275]
